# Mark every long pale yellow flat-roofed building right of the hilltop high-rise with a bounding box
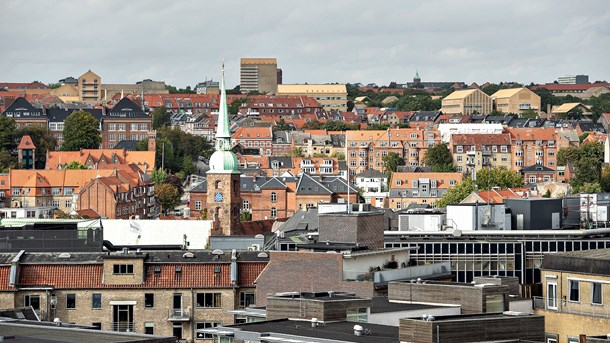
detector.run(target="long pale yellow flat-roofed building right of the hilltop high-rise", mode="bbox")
[277,84,347,112]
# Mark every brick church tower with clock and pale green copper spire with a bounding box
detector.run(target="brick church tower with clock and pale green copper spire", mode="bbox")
[207,64,241,235]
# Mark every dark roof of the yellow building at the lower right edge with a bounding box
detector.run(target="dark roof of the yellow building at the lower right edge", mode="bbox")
[542,249,610,276]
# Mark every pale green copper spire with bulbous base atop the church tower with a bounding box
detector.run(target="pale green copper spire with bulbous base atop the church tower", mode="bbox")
[208,63,239,173]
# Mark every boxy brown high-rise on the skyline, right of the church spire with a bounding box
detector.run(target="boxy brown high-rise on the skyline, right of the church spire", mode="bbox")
[240,58,278,93]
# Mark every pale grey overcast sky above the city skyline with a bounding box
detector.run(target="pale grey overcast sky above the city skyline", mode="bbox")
[0,0,610,88]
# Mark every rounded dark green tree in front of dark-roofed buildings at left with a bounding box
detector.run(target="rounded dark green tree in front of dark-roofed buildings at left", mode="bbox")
[61,110,102,151]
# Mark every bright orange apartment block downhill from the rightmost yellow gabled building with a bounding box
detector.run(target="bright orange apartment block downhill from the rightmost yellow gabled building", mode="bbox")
[506,128,569,171]
